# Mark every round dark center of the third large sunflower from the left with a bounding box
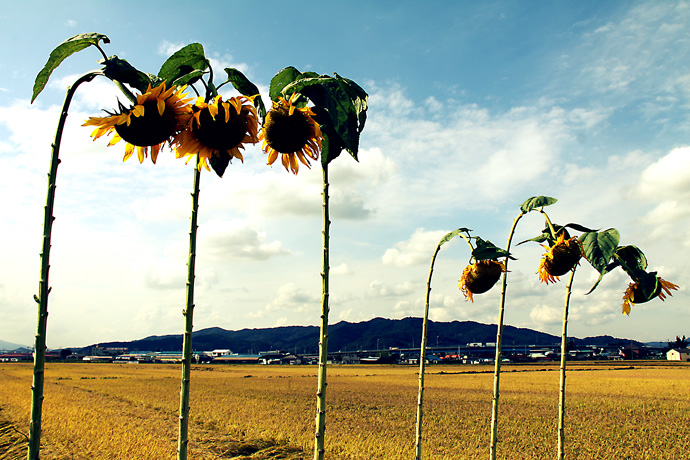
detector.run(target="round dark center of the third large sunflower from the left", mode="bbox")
[264,107,312,153]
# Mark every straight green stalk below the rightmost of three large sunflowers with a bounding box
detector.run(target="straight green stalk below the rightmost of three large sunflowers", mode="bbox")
[314,162,331,460]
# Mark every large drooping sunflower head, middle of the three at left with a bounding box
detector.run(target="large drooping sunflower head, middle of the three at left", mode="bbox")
[172,96,259,176]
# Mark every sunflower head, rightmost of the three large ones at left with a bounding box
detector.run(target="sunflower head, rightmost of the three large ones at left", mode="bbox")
[259,93,323,174]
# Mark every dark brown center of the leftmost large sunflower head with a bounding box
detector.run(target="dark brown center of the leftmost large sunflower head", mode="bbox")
[115,100,177,147]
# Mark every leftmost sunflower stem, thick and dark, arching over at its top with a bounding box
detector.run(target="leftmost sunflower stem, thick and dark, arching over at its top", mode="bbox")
[27,71,103,460]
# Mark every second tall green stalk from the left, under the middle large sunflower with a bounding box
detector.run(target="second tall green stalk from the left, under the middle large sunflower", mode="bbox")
[177,162,201,460]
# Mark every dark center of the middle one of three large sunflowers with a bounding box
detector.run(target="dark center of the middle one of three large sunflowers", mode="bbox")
[192,104,249,151]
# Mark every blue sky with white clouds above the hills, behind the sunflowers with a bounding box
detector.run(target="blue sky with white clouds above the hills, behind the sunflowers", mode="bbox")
[0,1,690,347]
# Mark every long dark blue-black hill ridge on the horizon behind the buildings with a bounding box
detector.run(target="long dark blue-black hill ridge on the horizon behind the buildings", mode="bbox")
[85,318,639,354]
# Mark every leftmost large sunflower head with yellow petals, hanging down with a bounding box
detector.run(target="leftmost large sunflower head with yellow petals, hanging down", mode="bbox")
[82,82,191,163]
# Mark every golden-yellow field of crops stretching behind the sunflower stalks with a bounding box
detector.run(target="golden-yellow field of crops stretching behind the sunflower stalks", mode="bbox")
[0,362,690,460]
